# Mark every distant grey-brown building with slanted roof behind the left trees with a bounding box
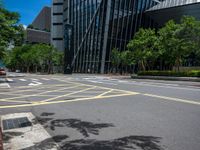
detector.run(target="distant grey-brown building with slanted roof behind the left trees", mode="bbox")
[26,6,51,44]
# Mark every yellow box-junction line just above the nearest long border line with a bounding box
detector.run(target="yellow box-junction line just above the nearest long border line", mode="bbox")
[0,85,80,100]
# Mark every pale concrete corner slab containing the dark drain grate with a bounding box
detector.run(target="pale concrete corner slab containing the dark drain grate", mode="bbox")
[1,112,58,150]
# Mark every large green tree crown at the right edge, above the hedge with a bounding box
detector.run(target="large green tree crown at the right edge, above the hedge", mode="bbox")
[159,16,200,71]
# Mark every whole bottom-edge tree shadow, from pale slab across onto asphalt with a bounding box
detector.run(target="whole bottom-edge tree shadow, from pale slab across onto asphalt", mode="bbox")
[23,135,164,150]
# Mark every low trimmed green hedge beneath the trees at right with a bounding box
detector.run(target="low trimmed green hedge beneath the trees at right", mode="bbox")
[138,70,200,77]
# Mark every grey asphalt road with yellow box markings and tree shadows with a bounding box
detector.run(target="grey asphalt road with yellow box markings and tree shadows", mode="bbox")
[0,74,200,150]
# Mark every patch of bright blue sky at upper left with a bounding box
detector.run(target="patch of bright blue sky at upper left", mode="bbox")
[3,0,51,26]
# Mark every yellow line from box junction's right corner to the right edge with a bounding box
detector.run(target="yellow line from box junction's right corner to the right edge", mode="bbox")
[142,94,200,105]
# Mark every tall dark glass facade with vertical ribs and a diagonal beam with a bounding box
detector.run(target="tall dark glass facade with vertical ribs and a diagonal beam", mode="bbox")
[53,0,199,73]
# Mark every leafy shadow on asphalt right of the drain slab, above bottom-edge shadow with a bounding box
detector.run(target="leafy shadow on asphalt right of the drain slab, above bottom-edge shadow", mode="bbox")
[50,119,114,137]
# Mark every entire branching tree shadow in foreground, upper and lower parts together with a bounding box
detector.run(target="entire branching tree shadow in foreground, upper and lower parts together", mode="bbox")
[29,113,164,150]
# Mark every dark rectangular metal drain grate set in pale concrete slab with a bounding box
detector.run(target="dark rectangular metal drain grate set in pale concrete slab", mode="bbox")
[3,117,32,130]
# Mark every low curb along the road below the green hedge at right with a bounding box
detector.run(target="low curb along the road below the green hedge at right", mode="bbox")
[131,75,200,82]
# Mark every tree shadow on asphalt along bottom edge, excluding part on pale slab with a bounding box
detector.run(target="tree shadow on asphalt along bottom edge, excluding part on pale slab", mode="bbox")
[61,136,164,150]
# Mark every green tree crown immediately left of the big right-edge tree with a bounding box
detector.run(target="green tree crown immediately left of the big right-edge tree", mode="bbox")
[127,29,158,71]
